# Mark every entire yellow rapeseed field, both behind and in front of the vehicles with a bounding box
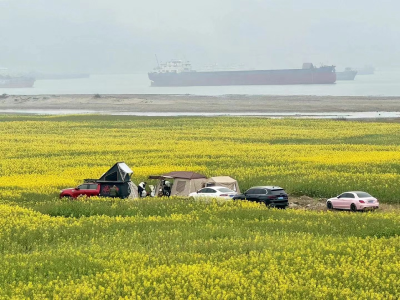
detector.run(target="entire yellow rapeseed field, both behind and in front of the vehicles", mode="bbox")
[0,116,400,299]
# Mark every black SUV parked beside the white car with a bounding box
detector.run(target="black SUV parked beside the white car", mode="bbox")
[233,186,289,208]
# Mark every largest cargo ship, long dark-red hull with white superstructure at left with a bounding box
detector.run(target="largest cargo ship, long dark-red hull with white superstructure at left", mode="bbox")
[148,60,336,86]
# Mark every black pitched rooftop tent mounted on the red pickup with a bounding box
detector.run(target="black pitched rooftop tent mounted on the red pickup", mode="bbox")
[96,162,138,198]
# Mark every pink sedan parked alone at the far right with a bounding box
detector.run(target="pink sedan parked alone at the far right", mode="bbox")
[326,191,379,211]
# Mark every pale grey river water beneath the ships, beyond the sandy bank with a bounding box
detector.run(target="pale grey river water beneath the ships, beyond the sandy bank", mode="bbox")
[0,70,400,96]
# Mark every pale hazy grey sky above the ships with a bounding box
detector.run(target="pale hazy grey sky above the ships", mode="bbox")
[0,0,400,73]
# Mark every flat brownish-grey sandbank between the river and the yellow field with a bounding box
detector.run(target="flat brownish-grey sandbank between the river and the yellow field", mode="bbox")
[0,95,400,113]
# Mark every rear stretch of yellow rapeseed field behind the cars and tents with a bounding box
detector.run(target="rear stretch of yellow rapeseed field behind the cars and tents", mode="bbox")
[0,116,400,203]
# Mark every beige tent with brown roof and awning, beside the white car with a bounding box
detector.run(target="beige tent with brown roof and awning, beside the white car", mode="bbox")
[149,171,207,196]
